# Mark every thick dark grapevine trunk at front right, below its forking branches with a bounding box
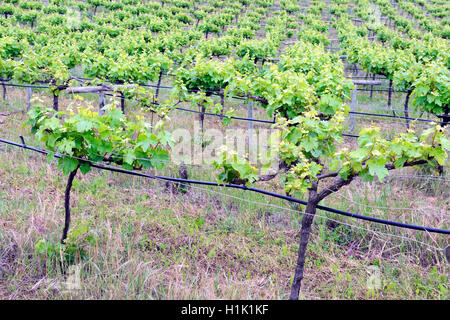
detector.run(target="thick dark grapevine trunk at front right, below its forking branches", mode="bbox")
[289,183,319,300]
